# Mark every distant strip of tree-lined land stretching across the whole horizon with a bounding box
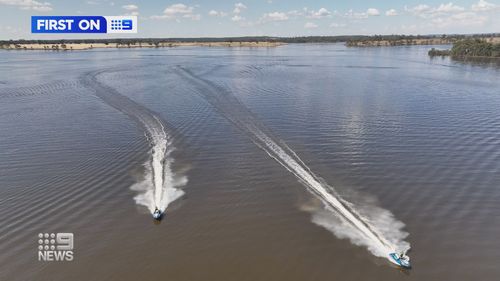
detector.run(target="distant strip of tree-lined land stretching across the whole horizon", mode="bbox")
[0,33,500,51]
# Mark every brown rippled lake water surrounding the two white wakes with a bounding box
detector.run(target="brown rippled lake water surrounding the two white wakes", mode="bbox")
[0,45,500,280]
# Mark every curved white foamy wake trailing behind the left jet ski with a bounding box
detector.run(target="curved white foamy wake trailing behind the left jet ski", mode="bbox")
[81,71,187,213]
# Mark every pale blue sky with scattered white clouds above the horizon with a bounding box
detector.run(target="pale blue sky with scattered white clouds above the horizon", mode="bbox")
[0,0,500,40]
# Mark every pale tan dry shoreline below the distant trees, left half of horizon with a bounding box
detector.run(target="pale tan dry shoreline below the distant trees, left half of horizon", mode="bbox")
[0,41,285,51]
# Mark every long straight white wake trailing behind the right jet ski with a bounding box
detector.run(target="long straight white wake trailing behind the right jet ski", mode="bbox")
[177,67,409,258]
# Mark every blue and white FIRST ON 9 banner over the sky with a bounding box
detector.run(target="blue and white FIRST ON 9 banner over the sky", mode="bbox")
[31,16,137,33]
